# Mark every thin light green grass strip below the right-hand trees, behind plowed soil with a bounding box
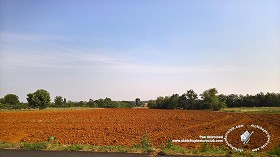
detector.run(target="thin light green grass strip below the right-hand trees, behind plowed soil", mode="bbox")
[221,107,280,114]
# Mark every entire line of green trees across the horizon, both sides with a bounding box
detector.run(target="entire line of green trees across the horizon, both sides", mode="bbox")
[0,88,280,110]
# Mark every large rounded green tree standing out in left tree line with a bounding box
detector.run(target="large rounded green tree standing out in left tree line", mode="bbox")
[26,89,51,109]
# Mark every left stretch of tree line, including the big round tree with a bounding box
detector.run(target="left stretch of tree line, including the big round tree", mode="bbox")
[0,89,135,109]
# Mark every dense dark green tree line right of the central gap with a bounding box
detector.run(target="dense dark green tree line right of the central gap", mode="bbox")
[148,88,280,110]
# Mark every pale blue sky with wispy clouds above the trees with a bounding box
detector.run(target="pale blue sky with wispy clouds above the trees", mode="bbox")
[0,0,280,102]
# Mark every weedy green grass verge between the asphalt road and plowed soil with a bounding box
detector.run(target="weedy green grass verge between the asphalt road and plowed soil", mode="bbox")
[0,140,280,157]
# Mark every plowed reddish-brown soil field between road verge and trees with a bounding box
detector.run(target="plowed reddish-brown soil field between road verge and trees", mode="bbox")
[0,109,280,150]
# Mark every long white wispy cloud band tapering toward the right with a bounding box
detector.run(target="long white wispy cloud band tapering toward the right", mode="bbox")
[2,48,233,74]
